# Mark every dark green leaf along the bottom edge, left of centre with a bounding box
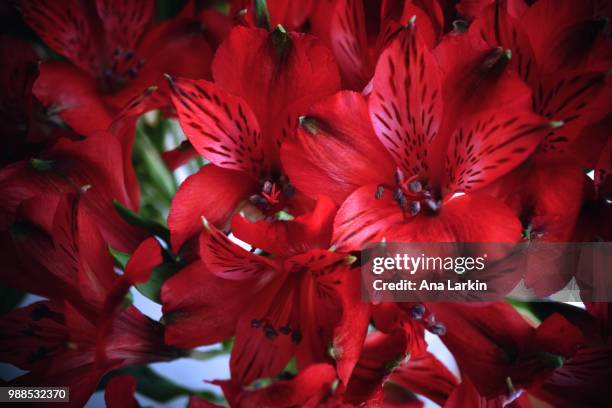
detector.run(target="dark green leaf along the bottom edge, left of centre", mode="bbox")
[98,365,223,403]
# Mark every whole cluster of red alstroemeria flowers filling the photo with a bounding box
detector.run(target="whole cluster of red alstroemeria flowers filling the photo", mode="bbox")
[0,0,612,407]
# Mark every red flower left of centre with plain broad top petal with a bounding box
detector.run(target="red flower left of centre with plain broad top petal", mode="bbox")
[168,27,339,250]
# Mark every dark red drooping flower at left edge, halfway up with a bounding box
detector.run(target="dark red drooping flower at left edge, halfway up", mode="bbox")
[0,132,145,252]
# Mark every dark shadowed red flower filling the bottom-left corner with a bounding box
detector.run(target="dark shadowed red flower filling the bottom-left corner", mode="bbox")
[0,196,176,406]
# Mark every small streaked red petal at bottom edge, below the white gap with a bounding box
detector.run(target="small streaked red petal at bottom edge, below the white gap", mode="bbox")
[389,353,457,405]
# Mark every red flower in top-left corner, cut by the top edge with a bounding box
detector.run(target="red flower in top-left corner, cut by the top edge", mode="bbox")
[20,0,218,134]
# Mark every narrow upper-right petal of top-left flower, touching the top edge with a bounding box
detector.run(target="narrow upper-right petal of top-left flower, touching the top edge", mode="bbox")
[96,0,155,56]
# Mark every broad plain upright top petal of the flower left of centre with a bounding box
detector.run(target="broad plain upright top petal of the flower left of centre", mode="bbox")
[214,27,340,164]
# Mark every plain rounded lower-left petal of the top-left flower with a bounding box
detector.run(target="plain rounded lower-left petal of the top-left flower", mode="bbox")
[33,61,113,135]
